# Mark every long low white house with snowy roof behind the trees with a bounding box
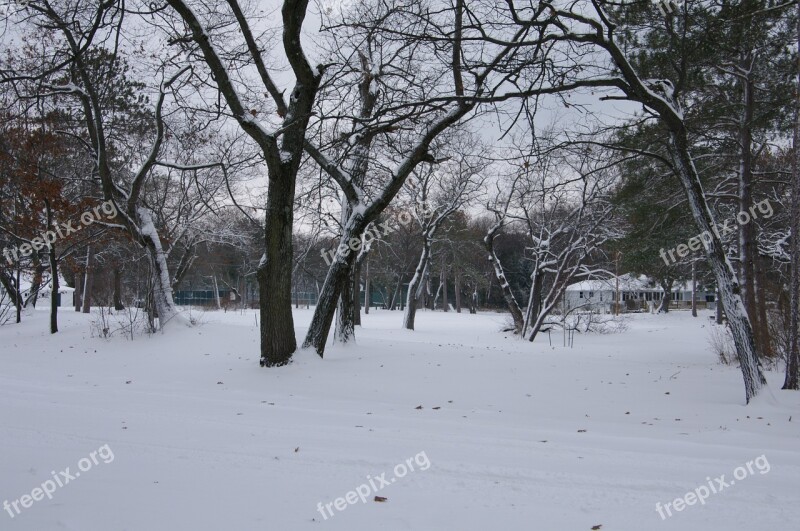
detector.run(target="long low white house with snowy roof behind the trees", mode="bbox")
[562,274,715,313]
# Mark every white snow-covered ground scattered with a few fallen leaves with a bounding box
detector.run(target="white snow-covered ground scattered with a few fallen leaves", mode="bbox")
[0,310,800,531]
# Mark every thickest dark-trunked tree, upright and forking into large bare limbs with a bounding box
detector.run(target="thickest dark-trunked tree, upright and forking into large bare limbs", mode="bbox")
[167,0,325,367]
